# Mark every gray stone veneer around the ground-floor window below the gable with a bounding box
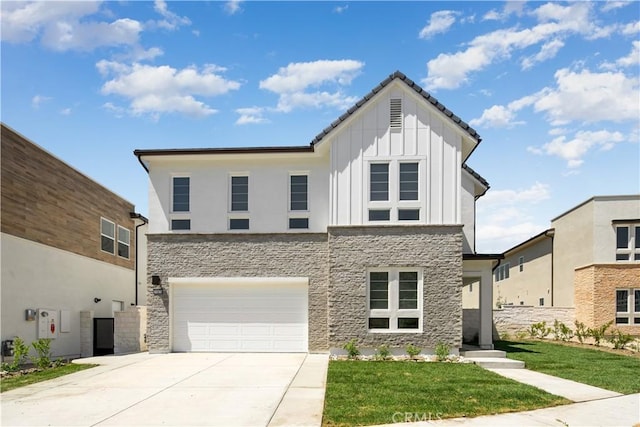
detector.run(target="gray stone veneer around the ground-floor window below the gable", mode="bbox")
[328,225,462,349]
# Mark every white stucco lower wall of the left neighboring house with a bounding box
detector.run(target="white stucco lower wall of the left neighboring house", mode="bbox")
[0,233,135,357]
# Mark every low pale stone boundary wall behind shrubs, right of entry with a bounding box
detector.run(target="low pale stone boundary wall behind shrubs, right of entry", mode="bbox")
[493,305,575,339]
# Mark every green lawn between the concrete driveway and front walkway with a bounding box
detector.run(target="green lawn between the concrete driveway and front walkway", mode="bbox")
[323,361,570,426]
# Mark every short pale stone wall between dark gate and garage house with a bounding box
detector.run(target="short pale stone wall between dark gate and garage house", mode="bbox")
[113,306,147,354]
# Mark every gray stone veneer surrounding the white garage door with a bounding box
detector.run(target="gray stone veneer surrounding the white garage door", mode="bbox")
[147,233,328,353]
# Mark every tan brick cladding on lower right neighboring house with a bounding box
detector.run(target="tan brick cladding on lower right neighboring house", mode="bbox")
[574,263,640,335]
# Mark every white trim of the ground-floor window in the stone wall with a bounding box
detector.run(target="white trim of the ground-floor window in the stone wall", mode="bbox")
[366,267,424,334]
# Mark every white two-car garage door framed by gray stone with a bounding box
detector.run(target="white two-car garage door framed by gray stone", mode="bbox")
[170,278,308,352]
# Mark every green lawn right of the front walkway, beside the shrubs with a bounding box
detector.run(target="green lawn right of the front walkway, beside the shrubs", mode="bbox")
[495,341,640,394]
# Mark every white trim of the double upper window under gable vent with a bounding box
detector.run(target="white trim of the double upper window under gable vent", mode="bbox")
[362,156,427,225]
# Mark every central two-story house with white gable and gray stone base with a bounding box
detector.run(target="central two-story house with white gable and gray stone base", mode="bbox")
[135,72,497,352]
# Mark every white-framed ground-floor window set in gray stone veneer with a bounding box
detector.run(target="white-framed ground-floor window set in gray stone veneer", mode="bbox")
[367,268,423,333]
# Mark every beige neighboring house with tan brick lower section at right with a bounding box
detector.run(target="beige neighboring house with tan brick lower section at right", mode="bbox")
[493,195,640,334]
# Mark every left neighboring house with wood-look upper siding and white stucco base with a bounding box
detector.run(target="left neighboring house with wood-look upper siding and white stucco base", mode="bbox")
[1,124,146,357]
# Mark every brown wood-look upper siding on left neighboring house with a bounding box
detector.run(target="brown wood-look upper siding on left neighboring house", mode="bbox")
[0,125,135,269]
